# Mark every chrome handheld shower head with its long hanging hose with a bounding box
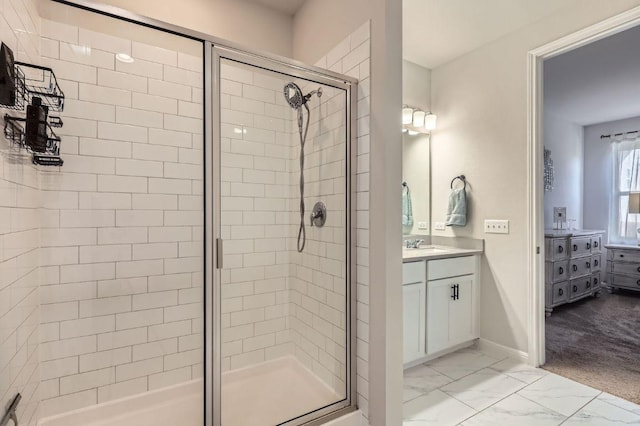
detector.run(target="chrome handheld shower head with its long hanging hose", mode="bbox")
[284,82,322,253]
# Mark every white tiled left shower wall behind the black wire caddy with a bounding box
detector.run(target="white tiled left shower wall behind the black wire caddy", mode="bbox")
[0,0,42,425]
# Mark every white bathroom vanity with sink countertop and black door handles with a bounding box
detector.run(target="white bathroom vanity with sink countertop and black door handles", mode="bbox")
[402,246,482,368]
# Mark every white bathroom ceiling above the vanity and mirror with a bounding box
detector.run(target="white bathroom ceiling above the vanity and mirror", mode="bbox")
[403,0,569,68]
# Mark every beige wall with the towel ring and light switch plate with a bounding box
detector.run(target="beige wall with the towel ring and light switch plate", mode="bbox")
[431,0,640,351]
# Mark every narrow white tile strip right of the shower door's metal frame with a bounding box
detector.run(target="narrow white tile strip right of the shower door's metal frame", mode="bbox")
[316,21,371,419]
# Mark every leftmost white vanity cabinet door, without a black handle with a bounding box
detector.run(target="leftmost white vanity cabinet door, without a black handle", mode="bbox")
[402,282,426,364]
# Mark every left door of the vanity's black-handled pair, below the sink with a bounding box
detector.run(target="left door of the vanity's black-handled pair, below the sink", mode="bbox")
[427,279,455,354]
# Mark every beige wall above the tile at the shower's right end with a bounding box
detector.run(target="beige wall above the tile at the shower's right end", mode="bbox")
[292,0,372,64]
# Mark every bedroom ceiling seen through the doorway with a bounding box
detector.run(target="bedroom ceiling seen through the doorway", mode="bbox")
[544,27,640,126]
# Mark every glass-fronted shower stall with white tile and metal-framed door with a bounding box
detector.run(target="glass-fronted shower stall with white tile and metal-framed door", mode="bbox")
[16,1,357,426]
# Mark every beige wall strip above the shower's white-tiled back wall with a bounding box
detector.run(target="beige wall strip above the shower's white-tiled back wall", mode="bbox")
[41,0,293,57]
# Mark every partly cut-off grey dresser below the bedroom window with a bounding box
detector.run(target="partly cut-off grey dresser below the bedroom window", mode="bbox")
[605,244,640,292]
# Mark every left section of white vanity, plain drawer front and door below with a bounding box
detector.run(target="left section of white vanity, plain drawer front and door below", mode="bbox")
[402,260,427,364]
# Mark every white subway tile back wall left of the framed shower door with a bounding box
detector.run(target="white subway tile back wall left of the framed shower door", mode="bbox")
[34,20,204,417]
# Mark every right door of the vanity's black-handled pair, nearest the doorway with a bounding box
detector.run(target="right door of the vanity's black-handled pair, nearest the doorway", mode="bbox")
[449,276,474,345]
